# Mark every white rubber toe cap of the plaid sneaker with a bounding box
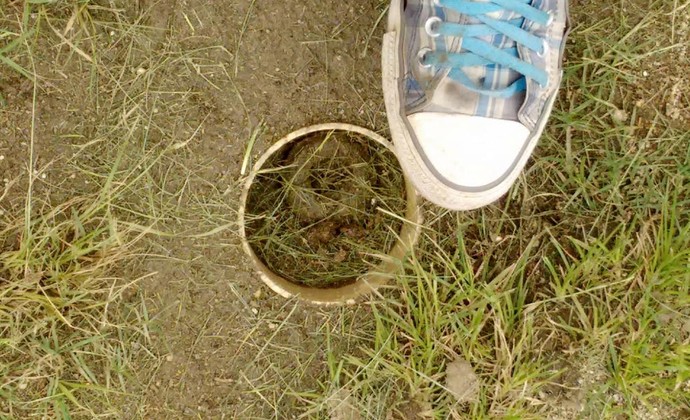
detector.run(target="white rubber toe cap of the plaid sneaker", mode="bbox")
[408,112,530,191]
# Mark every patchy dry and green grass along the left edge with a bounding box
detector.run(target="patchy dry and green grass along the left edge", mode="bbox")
[0,0,228,419]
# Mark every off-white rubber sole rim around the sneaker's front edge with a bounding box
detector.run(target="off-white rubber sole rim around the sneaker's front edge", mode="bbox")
[381,0,555,210]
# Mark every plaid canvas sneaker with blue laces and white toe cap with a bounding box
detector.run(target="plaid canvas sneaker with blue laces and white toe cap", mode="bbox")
[382,0,568,210]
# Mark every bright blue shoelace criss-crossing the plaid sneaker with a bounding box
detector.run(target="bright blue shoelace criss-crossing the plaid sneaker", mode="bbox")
[419,0,552,98]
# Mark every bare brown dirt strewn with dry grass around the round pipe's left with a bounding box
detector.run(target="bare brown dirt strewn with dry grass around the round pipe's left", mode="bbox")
[0,0,690,419]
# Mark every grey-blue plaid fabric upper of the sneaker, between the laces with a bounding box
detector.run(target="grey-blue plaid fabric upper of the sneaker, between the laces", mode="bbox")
[403,0,566,121]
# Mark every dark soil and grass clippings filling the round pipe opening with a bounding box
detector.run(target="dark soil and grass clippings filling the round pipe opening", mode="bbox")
[246,131,405,288]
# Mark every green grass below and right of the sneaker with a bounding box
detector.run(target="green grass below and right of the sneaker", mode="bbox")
[300,1,690,418]
